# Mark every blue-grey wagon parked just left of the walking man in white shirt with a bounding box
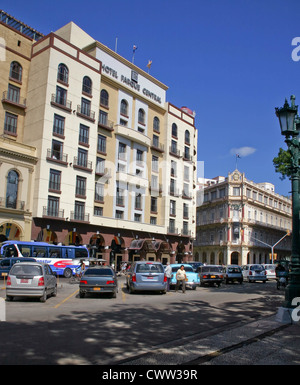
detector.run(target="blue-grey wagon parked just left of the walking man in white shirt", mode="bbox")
[126,261,167,294]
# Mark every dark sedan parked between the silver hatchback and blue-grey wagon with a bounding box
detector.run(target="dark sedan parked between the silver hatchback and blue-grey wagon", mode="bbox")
[79,265,118,298]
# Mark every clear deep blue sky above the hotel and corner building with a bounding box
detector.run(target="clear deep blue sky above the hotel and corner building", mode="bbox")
[0,0,300,195]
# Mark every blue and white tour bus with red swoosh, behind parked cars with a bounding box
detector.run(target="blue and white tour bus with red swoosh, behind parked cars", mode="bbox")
[0,240,89,278]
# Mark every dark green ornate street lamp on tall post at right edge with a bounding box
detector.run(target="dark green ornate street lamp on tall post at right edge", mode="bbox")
[275,95,300,308]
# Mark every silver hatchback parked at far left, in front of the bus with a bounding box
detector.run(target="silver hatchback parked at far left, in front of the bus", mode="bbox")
[6,262,57,302]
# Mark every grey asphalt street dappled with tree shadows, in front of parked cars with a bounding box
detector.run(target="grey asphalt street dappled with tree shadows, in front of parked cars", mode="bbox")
[0,277,284,365]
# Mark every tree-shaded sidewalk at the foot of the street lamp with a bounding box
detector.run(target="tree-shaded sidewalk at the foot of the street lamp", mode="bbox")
[121,315,300,365]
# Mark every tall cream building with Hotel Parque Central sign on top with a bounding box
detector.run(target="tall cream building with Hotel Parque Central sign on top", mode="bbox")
[0,12,197,266]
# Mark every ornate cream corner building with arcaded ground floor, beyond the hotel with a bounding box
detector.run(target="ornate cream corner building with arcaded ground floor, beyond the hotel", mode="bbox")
[194,170,292,265]
